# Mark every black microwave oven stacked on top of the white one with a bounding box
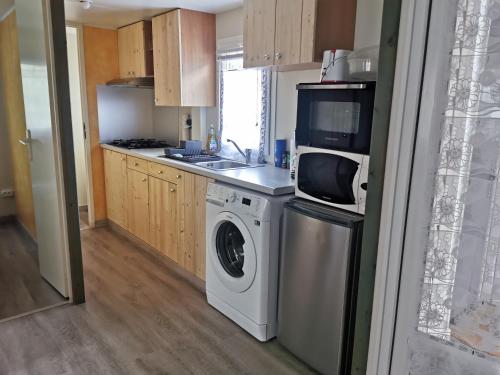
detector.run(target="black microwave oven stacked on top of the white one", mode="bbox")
[295,82,375,155]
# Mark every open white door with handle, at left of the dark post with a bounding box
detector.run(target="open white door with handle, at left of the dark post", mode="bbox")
[15,0,68,297]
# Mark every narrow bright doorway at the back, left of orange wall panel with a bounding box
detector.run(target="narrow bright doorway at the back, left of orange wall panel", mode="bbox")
[66,25,95,230]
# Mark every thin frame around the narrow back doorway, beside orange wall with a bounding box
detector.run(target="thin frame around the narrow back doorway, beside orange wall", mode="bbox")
[66,21,95,232]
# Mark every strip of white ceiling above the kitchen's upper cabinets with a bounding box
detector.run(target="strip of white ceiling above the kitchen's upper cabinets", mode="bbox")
[63,0,243,28]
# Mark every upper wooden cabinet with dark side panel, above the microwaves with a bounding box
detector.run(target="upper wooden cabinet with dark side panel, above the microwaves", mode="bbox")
[243,0,356,68]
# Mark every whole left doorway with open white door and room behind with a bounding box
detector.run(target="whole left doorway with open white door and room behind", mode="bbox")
[0,0,84,322]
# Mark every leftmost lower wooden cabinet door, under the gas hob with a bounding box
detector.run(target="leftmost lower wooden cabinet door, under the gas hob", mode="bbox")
[104,150,128,228]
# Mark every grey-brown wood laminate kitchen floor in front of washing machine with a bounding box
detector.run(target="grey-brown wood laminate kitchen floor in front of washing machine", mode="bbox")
[0,227,311,375]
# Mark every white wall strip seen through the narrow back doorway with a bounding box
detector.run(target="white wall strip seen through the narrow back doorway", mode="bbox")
[66,27,88,207]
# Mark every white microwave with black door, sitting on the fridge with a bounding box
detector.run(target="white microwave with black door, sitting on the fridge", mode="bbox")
[295,146,370,215]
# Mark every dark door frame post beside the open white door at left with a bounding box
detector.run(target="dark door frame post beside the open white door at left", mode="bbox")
[46,0,85,304]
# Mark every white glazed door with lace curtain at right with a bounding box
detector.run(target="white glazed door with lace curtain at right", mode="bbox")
[390,0,500,375]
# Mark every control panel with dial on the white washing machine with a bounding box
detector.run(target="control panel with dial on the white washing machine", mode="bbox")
[207,184,268,219]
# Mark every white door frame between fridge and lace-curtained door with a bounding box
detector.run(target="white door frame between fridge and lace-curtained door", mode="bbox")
[366,0,432,375]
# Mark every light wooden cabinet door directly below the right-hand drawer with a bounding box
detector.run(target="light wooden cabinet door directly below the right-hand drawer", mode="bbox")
[149,177,179,262]
